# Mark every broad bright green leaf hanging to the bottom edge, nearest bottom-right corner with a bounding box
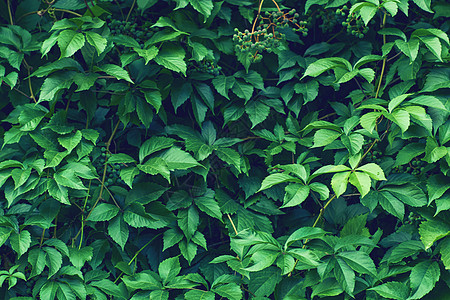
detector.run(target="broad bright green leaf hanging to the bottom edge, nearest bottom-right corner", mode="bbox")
[408,260,441,299]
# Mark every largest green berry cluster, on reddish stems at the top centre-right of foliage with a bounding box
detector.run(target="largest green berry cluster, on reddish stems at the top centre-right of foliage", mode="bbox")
[233,9,308,62]
